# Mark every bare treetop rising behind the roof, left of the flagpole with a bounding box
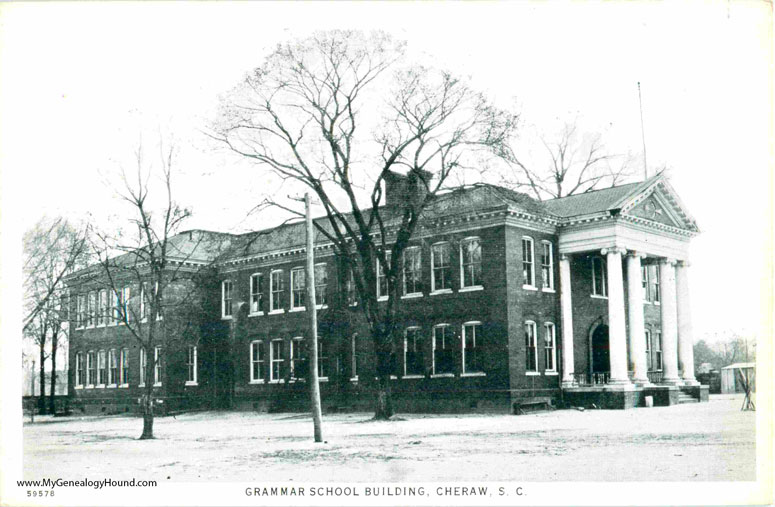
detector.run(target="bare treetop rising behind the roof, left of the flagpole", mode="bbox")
[501,121,633,200]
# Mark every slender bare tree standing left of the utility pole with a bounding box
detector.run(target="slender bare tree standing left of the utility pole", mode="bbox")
[88,143,227,439]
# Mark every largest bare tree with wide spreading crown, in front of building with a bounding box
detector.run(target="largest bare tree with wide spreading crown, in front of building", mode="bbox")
[211,31,516,419]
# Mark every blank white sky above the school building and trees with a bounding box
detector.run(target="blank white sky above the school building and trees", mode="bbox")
[0,2,773,346]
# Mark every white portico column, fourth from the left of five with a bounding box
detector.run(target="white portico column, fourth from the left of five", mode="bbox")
[659,259,681,385]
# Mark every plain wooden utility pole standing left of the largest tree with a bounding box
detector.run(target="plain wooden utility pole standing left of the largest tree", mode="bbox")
[304,192,323,443]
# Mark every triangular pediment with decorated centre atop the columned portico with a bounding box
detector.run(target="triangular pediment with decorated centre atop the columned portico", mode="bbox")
[620,174,699,232]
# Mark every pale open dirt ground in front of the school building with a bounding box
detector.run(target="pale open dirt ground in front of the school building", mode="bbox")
[24,395,756,482]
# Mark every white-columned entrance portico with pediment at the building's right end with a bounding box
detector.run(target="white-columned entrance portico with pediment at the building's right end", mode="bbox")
[558,175,702,408]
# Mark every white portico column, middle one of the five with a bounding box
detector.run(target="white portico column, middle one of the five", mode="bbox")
[627,252,649,384]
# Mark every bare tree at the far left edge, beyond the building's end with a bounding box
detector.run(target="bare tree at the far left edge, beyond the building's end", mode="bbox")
[23,217,87,412]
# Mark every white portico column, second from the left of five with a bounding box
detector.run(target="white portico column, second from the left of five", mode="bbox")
[601,248,630,385]
